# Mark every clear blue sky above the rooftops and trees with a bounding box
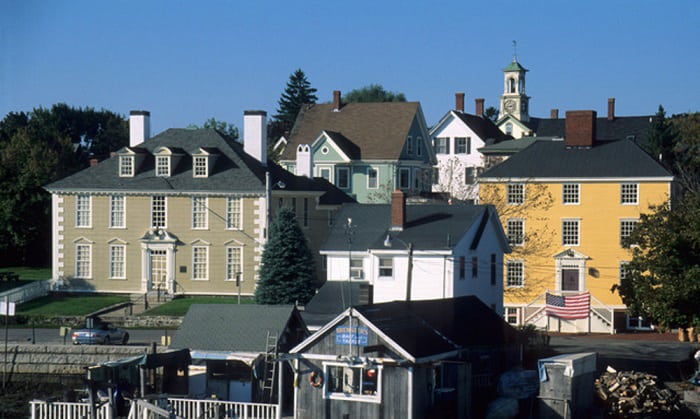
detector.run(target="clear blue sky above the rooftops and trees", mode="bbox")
[0,0,700,134]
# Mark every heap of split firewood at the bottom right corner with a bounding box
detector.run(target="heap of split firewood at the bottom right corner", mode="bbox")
[595,367,681,418]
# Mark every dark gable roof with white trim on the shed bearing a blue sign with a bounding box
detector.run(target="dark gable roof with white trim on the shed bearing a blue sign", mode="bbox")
[290,296,516,362]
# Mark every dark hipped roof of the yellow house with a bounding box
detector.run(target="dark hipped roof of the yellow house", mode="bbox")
[480,139,672,181]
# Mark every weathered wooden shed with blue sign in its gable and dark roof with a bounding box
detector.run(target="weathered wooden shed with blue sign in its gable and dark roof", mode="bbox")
[289,296,518,419]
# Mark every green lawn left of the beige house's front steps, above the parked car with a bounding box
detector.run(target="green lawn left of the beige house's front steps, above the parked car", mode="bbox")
[17,295,129,316]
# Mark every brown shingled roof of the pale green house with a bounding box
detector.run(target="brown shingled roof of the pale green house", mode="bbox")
[281,102,420,160]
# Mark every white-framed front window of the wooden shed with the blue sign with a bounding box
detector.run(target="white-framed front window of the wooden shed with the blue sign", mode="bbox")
[325,364,381,400]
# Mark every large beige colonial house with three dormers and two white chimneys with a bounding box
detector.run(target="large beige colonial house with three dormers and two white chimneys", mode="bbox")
[46,111,352,295]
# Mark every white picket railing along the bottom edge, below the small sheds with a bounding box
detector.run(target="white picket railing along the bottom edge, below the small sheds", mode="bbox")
[29,398,279,419]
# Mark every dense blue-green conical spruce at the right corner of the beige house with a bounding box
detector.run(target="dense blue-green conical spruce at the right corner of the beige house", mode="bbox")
[255,208,316,304]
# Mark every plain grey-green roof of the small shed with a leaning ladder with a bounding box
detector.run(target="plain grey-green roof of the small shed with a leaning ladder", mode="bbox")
[170,304,303,353]
